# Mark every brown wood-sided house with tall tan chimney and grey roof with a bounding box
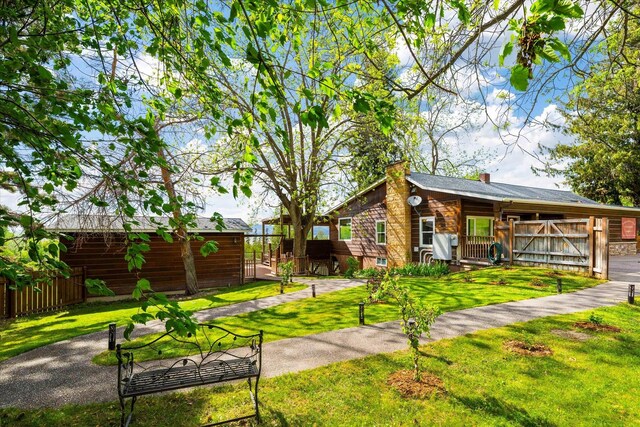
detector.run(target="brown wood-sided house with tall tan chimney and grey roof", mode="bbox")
[326,162,640,276]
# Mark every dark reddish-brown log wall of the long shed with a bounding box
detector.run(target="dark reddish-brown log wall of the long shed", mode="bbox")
[61,233,244,295]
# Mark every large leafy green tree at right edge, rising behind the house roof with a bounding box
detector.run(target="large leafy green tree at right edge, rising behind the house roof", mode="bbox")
[548,2,640,206]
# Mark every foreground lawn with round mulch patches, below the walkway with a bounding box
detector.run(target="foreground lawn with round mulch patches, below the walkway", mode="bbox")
[0,304,640,427]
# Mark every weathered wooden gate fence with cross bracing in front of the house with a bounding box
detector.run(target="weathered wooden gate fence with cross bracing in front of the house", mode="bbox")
[495,217,609,279]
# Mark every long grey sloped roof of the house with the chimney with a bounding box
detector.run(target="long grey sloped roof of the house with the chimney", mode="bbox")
[407,173,603,207]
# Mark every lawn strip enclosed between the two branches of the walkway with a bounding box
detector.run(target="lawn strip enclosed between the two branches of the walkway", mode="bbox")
[94,267,602,364]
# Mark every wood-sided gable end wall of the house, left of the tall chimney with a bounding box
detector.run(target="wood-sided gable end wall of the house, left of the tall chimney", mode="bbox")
[329,184,387,260]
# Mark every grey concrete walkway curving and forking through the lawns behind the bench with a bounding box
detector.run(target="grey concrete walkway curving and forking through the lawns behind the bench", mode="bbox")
[0,258,640,408]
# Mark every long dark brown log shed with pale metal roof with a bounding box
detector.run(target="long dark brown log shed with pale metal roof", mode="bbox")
[48,215,251,295]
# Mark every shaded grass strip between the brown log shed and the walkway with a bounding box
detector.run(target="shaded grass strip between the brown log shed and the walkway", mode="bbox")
[0,282,306,361]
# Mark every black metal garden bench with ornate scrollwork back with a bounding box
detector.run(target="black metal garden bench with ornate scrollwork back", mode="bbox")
[109,323,262,427]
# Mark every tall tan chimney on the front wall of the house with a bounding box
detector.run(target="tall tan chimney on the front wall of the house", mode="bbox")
[387,161,411,268]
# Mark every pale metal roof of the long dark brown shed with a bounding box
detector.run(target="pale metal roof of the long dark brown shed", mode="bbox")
[47,215,251,233]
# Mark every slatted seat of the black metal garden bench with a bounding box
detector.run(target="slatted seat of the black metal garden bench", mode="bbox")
[123,358,258,397]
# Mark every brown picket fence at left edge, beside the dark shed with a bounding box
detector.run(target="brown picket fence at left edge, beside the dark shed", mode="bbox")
[0,267,87,318]
